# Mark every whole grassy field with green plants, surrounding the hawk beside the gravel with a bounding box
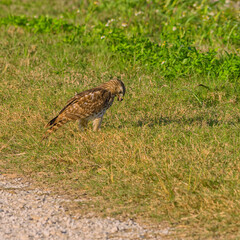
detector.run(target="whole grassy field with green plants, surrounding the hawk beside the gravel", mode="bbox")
[0,0,240,239]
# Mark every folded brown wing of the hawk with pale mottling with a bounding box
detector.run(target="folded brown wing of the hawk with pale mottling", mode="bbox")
[59,88,111,120]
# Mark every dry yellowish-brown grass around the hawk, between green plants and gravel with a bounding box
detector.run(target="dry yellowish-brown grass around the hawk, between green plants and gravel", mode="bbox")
[0,60,239,239]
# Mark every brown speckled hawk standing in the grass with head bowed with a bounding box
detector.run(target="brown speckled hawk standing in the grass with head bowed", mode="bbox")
[43,78,126,139]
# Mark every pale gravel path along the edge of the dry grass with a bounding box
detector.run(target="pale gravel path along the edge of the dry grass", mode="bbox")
[0,175,169,240]
